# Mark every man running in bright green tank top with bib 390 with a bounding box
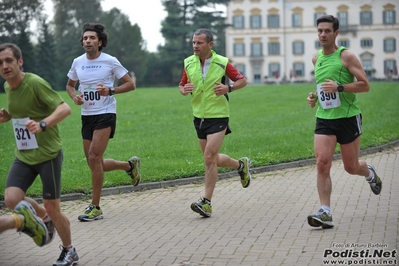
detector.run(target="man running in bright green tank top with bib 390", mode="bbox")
[307,15,382,228]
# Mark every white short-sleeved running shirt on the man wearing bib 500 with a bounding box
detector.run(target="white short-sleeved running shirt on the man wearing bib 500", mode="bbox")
[67,52,128,115]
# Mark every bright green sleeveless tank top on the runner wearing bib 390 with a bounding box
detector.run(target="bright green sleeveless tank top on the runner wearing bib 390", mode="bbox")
[315,46,361,119]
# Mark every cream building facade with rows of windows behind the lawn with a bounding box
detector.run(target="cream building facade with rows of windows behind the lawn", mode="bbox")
[226,0,399,84]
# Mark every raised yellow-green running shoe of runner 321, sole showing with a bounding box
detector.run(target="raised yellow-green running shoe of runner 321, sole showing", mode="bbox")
[14,200,48,247]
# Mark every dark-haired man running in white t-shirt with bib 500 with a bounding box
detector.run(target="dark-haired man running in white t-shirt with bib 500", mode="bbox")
[66,23,141,221]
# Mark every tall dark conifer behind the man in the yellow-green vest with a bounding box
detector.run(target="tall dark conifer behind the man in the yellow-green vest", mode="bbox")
[159,0,230,85]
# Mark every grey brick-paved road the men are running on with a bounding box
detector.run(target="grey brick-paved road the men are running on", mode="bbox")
[0,147,399,266]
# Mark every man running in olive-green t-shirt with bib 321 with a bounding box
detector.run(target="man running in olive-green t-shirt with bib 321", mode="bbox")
[0,43,79,266]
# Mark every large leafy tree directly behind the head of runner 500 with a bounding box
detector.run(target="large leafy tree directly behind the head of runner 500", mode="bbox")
[53,0,147,86]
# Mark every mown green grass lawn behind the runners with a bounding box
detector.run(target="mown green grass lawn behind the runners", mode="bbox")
[0,82,399,200]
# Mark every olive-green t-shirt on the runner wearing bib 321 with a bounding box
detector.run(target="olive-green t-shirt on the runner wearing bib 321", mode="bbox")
[4,73,64,165]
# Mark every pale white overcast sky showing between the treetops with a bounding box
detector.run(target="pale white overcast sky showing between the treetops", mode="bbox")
[44,0,167,52]
